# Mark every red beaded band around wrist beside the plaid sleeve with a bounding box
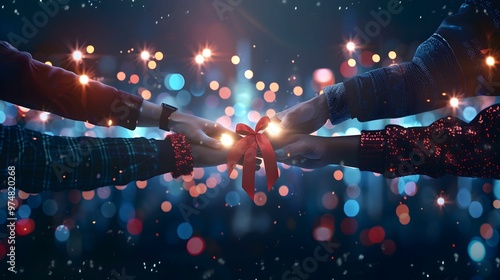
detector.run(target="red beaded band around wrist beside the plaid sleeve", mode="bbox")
[168,133,194,178]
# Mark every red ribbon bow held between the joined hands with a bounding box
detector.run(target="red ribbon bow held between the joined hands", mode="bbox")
[227,116,278,200]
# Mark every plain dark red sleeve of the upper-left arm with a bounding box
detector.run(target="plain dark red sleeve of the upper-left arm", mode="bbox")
[0,41,143,129]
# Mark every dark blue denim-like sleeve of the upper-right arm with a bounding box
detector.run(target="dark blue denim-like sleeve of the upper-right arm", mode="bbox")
[324,0,500,124]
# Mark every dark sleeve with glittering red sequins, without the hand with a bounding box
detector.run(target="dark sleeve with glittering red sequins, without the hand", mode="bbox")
[359,104,500,179]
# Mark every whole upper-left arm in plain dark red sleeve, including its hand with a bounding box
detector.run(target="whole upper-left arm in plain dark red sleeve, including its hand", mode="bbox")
[0,41,237,149]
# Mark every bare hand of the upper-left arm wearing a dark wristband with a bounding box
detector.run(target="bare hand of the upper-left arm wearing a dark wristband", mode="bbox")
[169,111,241,149]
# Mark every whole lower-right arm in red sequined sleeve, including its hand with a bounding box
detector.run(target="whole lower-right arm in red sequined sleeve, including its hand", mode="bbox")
[276,104,500,179]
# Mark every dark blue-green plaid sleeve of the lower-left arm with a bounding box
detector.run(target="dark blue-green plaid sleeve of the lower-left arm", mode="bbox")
[0,126,192,193]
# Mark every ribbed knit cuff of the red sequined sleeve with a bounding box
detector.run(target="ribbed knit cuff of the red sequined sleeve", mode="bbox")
[359,130,386,174]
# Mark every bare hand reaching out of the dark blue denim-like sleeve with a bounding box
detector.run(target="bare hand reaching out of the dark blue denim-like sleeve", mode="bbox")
[273,94,330,134]
